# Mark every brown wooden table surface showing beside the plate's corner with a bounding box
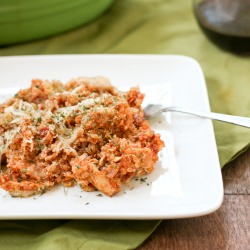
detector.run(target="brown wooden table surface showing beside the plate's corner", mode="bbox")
[138,149,250,250]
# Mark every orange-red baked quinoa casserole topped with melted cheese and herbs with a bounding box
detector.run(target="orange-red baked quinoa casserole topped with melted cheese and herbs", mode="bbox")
[0,77,164,197]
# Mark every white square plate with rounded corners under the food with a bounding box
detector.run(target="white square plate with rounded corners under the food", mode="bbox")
[0,55,223,219]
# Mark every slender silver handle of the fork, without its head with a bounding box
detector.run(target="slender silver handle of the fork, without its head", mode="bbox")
[162,107,250,128]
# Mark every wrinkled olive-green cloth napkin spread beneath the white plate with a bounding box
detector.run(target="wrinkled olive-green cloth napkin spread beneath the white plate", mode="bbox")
[0,0,250,250]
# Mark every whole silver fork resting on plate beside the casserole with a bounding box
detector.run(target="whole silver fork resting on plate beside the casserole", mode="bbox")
[143,104,250,128]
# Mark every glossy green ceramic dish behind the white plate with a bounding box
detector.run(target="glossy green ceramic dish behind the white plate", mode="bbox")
[0,0,114,45]
